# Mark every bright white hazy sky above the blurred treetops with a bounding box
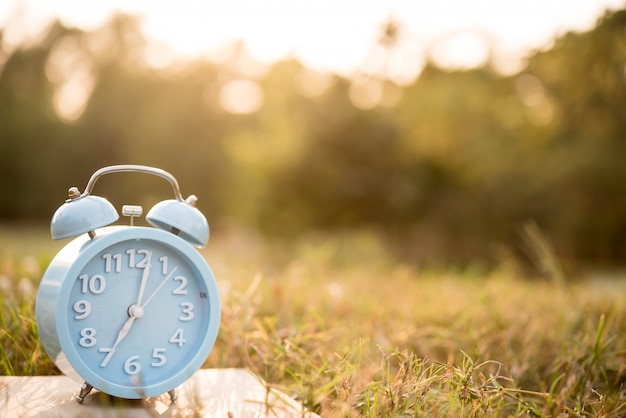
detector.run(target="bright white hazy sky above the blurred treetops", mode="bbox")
[0,0,626,83]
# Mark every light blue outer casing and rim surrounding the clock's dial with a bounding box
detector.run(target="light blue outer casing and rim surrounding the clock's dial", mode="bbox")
[36,226,221,399]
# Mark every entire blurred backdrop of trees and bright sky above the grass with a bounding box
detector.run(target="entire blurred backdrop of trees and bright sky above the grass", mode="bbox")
[0,0,626,268]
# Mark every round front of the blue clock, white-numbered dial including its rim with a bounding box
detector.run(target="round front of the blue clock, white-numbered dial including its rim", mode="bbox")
[37,227,219,398]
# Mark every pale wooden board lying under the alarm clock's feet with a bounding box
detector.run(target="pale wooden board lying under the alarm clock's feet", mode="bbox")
[0,369,317,418]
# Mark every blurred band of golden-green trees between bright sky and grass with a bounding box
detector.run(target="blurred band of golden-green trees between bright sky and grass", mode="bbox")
[0,11,626,270]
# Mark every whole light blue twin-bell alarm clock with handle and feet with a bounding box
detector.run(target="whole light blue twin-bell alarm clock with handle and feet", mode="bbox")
[36,165,220,403]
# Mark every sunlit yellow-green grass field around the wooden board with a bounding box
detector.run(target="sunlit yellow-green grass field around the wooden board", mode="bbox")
[0,226,626,417]
